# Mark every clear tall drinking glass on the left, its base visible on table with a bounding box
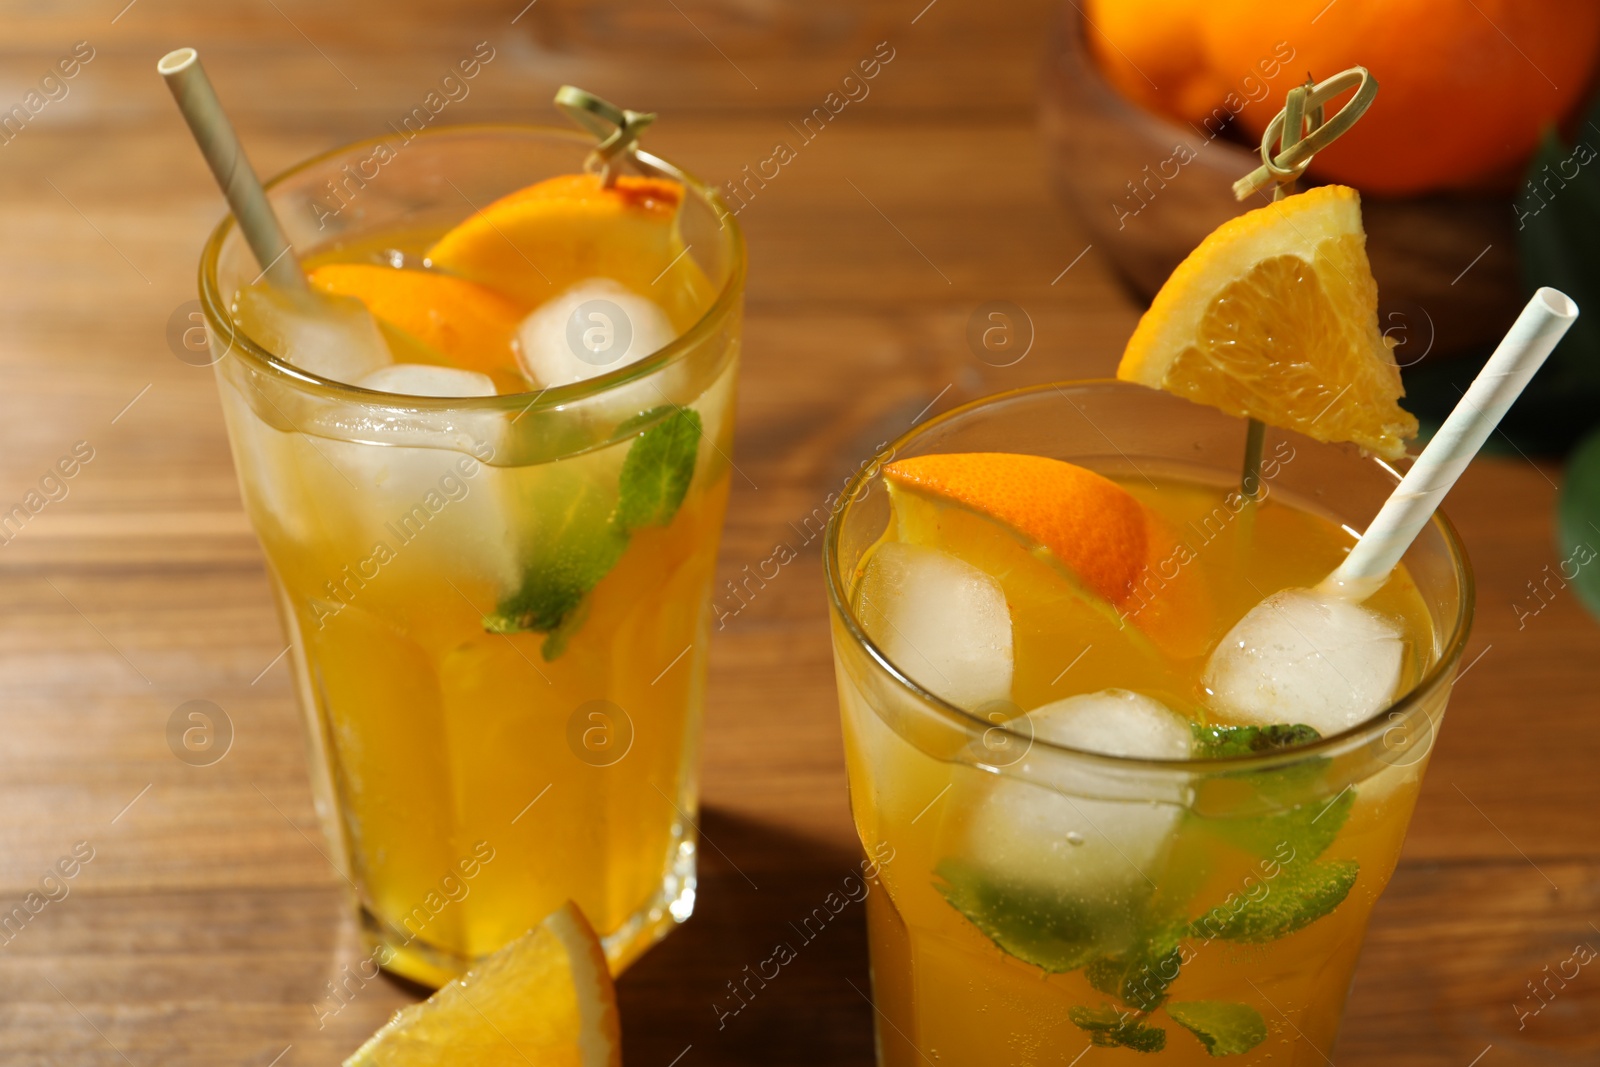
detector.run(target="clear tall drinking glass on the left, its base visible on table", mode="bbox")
[200,126,744,984]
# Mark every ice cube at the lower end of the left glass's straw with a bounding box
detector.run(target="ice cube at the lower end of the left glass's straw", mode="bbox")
[234,285,394,384]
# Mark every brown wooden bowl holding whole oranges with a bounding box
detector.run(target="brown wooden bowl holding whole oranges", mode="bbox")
[1042,5,1523,358]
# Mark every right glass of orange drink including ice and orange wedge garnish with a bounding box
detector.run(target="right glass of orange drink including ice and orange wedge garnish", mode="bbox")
[824,190,1472,1067]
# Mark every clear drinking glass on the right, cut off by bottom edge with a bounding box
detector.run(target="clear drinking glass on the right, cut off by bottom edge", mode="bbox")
[826,381,1472,1067]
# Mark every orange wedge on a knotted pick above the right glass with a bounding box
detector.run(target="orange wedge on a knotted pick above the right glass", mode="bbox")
[1117,186,1418,459]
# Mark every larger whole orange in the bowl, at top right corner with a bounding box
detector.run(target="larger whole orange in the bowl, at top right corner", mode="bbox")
[1202,0,1600,195]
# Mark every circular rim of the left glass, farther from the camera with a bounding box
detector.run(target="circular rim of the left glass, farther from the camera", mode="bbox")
[200,122,747,418]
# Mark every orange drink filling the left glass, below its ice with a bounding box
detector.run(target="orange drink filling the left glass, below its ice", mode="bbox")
[209,156,738,985]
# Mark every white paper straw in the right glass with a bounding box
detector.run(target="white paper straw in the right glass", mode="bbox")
[1317,288,1578,600]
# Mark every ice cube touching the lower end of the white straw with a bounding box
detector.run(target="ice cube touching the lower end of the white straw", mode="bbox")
[1205,589,1405,737]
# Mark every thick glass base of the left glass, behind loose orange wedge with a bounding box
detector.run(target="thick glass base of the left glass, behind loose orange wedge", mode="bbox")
[360,835,698,989]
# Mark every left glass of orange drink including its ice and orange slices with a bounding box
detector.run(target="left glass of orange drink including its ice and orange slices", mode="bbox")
[200,126,744,985]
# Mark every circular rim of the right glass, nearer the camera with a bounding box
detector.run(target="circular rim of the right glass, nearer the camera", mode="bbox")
[822,378,1475,774]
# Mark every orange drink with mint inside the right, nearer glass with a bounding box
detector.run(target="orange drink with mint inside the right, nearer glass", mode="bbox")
[835,462,1437,1067]
